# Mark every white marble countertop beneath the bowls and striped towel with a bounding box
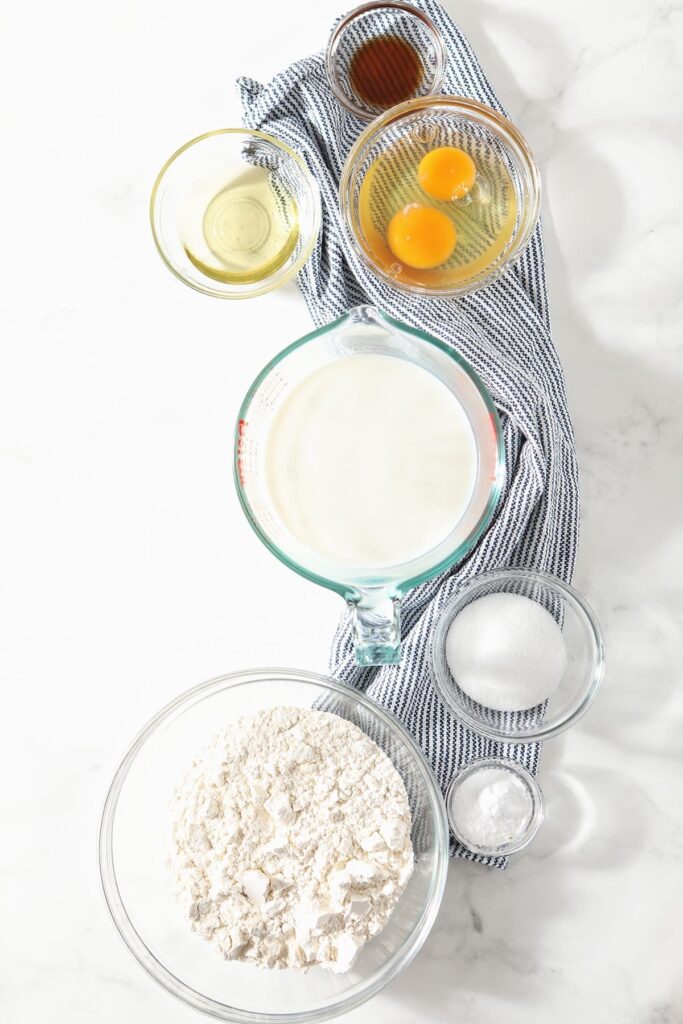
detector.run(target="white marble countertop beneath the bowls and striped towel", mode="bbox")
[0,0,683,1024]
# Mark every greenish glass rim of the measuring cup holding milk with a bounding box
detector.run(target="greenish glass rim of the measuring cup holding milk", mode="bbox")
[232,306,505,599]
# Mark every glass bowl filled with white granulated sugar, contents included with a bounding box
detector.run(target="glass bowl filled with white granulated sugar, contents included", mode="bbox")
[430,569,605,743]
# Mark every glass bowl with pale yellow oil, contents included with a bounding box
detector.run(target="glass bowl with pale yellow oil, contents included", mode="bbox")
[150,128,321,299]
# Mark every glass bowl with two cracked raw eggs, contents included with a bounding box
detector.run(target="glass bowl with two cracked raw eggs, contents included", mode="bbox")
[339,95,541,298]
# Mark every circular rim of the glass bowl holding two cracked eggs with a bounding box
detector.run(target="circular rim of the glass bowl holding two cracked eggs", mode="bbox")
[339,94,541,299]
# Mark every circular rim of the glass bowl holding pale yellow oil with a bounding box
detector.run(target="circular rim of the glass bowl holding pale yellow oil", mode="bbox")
[150,128,323,299]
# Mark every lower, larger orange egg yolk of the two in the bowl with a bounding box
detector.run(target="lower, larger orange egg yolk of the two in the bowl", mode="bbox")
[387,203,458,270]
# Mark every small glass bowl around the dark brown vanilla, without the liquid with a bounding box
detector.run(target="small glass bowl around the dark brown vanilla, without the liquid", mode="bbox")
[326,2,446,121]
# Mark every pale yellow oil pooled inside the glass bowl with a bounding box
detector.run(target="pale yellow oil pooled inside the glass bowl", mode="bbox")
[184,167,299,285]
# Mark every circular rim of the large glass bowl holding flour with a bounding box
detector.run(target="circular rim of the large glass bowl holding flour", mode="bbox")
[97,668,449,1024]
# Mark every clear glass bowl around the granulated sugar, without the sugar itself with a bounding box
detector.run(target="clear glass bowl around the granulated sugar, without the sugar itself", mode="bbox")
[429,569,605,743]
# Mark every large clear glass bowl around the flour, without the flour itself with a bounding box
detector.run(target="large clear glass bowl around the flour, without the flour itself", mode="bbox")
[99,669,449,1024]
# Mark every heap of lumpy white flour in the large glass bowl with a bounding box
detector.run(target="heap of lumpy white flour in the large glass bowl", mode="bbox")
[170,708,413,972]
